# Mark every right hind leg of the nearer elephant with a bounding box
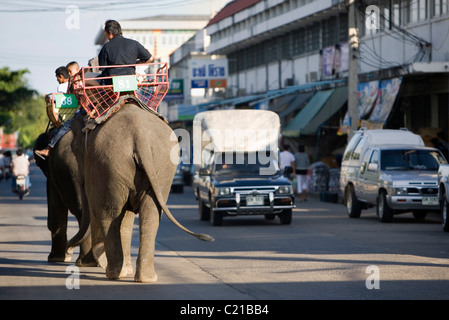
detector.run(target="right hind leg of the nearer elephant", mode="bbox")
[134,195,160,282]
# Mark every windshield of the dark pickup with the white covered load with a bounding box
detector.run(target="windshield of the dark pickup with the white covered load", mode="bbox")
[215,154,280,175]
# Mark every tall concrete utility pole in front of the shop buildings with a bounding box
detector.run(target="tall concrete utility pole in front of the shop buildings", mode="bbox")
[348,0,359,141]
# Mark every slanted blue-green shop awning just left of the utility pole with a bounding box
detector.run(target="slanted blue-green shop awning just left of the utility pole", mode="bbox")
[282,87,348,138]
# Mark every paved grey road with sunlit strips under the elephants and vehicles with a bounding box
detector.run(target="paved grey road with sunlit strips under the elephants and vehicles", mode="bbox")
[0,167,449,306]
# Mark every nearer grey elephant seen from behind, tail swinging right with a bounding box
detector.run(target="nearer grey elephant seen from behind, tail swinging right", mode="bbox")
[68,102,214,283]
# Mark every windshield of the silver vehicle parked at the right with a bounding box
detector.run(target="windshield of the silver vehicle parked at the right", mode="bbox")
[381,149,446,171]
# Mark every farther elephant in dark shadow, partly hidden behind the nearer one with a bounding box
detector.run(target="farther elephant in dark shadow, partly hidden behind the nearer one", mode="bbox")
[33,129,97,266]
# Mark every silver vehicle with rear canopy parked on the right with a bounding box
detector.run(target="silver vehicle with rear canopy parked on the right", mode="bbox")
[340,129,446,222]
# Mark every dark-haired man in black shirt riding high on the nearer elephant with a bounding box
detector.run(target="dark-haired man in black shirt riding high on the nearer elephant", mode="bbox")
[98,20,151,77]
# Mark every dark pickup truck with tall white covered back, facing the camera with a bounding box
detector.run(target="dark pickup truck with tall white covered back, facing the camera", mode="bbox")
[193,109,295,226]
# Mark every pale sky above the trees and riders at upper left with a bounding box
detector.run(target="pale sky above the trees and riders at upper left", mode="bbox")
[0,0,227,94]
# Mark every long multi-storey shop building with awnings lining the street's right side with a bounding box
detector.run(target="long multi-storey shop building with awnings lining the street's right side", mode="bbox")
[169,0,449,160]
